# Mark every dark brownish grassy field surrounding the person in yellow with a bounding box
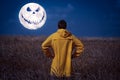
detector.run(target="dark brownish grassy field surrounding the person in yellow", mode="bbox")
[0,36,120,80]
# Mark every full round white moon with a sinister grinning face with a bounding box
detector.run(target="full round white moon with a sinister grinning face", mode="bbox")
[19,3,47,30]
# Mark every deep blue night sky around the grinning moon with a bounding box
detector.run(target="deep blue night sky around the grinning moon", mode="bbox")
[0,0,120,37]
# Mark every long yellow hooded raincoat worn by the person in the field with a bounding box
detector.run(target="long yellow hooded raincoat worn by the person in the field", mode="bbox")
[42,29,84,77]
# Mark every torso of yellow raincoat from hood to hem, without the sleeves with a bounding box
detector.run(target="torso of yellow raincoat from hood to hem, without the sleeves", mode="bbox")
[51,29,73,76]
